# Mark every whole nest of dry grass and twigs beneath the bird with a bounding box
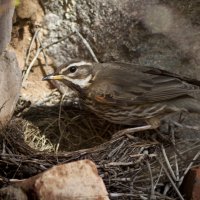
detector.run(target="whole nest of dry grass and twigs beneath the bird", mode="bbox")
[0,101,200,200]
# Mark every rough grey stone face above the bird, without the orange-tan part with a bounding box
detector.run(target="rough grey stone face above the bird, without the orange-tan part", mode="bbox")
[40,0,200,79]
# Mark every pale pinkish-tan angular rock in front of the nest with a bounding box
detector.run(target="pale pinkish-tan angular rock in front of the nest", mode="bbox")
[15,160,109,200]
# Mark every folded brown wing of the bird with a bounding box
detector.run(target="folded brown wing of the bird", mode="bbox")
[86,64,199,105]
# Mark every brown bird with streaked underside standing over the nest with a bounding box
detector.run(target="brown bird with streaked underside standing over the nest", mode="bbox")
[43,60,200,127]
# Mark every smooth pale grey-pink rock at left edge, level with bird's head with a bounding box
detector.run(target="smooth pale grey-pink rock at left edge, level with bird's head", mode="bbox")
[0,51,21,125]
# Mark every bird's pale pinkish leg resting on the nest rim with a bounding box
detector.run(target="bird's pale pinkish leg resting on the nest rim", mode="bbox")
[112,125,153,138]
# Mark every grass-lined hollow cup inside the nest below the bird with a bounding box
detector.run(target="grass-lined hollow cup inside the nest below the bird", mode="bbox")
[22,103,124,152]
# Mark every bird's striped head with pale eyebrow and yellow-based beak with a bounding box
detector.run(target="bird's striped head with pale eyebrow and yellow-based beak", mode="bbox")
[43,61,94,89]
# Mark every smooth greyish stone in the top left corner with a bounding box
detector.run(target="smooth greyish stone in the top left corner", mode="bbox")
[0,0,14,54]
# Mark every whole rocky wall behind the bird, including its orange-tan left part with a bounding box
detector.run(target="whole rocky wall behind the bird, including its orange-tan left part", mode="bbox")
[12,0,200,103]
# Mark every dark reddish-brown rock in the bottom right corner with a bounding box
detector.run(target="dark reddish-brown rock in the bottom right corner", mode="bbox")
[181,167,200,200]
